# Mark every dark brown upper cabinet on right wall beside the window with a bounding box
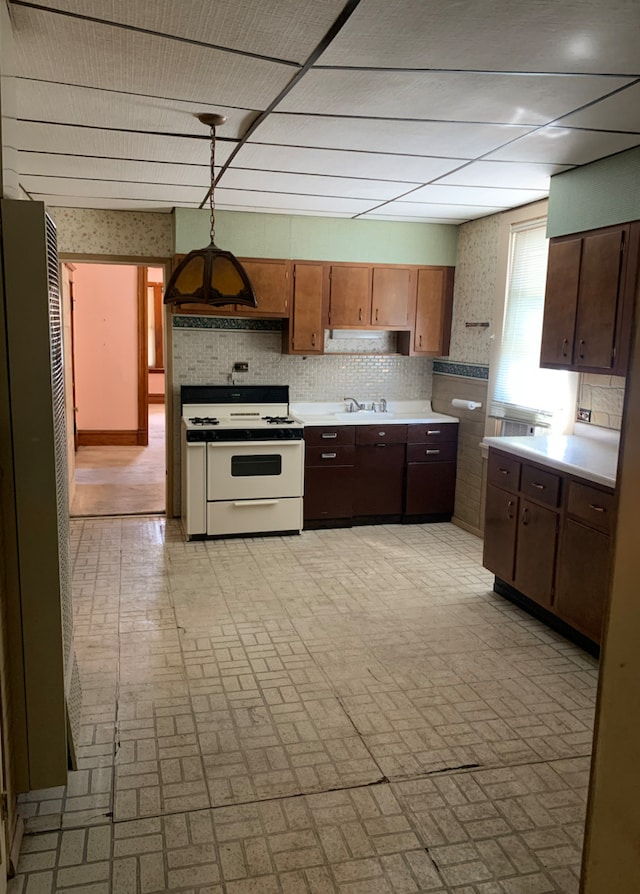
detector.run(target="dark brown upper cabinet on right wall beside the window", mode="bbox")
[540,223,640,375]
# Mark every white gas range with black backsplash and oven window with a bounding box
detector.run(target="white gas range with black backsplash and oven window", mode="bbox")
[180,385,304,540]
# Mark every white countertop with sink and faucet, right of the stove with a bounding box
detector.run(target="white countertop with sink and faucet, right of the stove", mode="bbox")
[289,400,459,425]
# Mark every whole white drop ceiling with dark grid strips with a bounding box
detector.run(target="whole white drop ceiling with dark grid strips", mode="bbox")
[9,0,640,224]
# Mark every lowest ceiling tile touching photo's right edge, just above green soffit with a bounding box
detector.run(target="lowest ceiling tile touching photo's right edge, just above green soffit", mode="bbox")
[489,127,640,165]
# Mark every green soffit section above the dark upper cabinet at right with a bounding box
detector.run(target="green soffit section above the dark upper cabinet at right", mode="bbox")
[547,148,640,237]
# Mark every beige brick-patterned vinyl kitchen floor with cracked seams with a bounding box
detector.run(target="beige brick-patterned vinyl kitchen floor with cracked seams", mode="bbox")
[9,518,597,894]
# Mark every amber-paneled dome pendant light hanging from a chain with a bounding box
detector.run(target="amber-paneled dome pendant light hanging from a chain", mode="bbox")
[164,113,258,307]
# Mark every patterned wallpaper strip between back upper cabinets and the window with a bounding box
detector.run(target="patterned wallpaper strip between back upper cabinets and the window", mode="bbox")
[449,214,500,364]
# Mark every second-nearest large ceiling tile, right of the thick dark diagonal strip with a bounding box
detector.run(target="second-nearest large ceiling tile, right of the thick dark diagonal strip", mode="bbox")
[277,70,631,125]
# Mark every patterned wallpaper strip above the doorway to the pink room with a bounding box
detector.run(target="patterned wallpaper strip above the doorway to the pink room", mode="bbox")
[48,208,173,258]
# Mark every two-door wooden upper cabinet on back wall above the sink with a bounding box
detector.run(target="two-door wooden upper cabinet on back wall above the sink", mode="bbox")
[327,264,416,329]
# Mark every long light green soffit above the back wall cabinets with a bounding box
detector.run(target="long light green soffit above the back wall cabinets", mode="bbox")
[174,208,458,266]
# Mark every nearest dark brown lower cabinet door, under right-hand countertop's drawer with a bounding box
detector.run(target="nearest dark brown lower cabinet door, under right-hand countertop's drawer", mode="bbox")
[555,518,611,643]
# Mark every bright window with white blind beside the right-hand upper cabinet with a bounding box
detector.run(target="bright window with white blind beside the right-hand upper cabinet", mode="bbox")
[490,220,576,428]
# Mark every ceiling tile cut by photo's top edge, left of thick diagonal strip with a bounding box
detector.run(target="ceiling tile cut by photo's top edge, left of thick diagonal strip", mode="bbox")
[40,0,344,62]
